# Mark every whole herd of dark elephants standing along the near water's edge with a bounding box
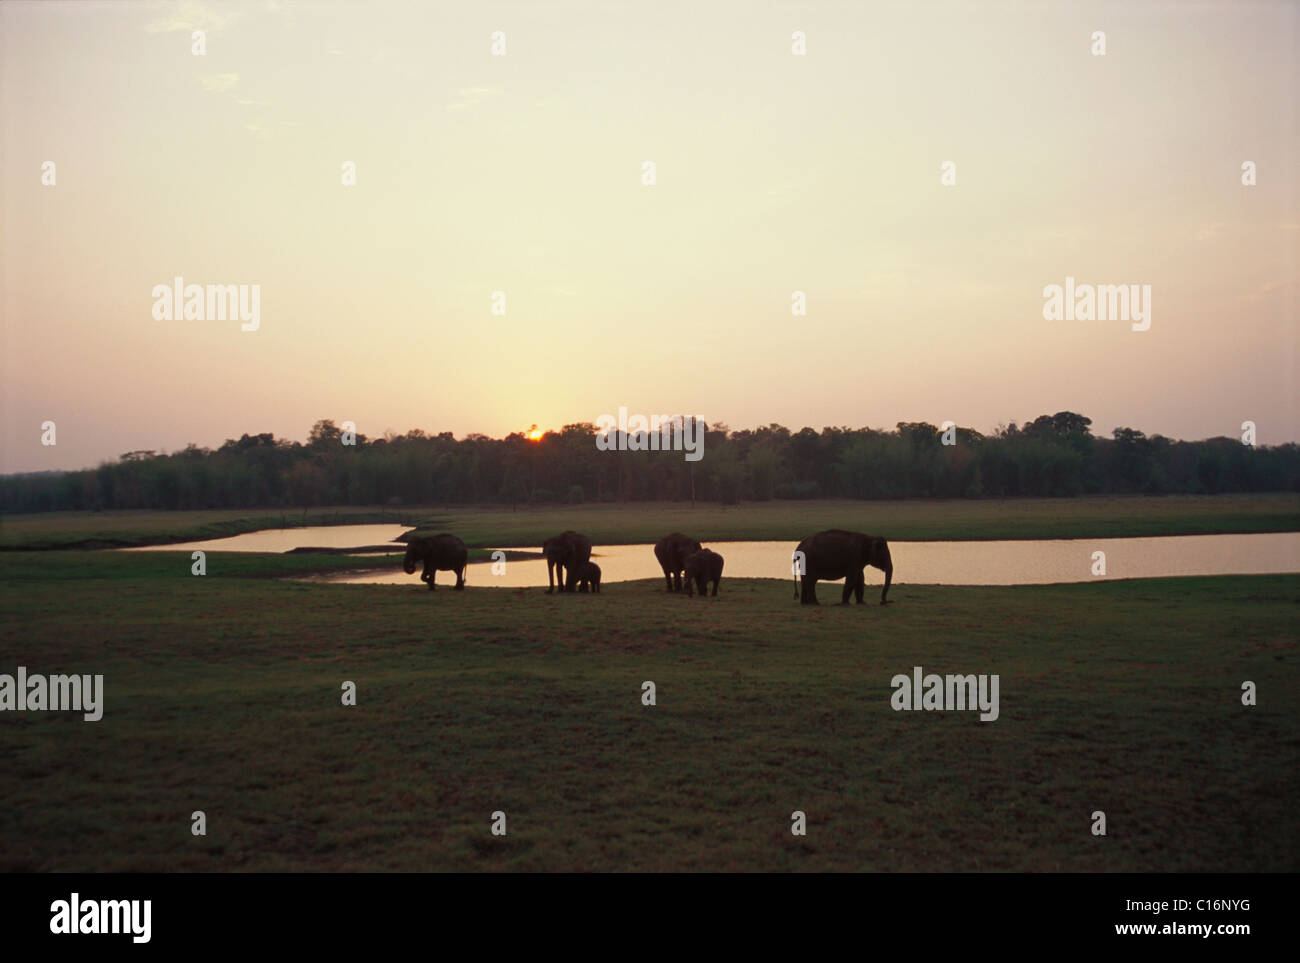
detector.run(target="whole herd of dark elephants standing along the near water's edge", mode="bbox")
[402,529,893,606]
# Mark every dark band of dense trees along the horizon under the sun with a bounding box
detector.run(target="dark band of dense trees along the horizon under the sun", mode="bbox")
[0,412,1300,512]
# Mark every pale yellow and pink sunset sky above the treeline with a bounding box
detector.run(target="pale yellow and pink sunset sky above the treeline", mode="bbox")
[0,0,1300,472]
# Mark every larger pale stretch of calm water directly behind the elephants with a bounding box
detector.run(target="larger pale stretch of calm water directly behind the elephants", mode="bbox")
[292,533,1300,590]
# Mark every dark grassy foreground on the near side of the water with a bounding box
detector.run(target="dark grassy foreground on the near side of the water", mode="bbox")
[0,548,1300,871]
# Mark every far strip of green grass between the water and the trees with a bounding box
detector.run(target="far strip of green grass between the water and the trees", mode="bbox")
[0,493,1300,548]
